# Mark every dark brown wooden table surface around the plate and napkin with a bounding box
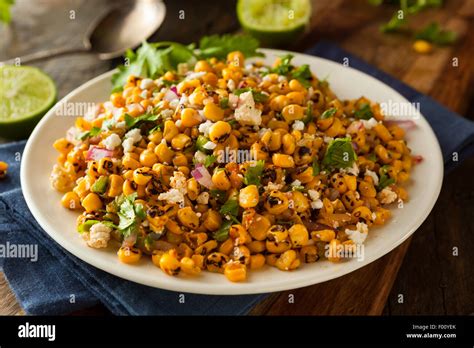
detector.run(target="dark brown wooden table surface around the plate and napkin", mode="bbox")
[0,0,474,315]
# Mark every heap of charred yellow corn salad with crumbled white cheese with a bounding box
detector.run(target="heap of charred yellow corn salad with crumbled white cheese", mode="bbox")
[51,51,415,281]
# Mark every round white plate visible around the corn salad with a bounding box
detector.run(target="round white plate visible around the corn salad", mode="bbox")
[21,50,443,295]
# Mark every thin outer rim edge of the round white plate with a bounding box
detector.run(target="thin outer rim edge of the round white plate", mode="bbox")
[20,49,444,295]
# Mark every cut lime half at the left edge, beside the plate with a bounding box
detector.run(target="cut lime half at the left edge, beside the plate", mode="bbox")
[0,65,56,139]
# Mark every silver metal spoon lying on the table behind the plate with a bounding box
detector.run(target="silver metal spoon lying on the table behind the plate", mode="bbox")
[0,0,166,64]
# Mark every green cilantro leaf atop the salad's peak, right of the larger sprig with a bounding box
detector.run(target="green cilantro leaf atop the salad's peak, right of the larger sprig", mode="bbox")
[198,34,264,59]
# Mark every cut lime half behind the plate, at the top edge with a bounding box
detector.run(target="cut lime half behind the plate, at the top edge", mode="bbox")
[237,0,311,46]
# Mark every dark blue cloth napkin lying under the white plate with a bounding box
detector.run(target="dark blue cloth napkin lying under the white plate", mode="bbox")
[0,42,474,315]
